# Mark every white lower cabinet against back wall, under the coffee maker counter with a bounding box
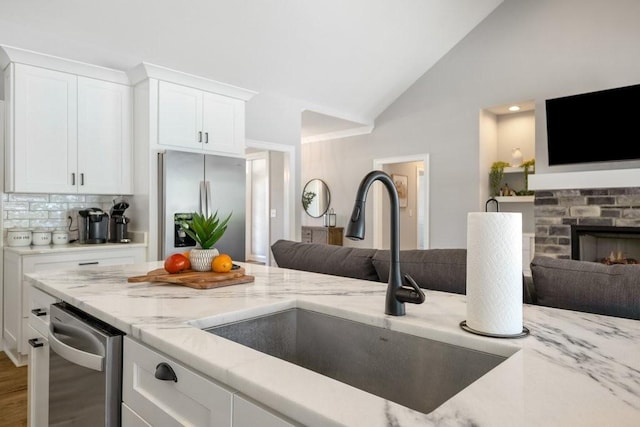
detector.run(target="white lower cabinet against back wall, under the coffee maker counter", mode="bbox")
[2,246,146,366]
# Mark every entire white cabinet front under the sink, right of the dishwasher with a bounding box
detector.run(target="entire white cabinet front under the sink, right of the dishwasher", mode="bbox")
[122,337,296,427]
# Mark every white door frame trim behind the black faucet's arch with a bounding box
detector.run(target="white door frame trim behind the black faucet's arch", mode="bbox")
[372,153,431,249]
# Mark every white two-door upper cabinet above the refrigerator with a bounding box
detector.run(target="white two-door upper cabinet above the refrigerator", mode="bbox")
[158,81,245,155]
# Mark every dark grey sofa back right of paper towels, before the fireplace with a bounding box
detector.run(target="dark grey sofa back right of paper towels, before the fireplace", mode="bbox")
[531,256,640,320]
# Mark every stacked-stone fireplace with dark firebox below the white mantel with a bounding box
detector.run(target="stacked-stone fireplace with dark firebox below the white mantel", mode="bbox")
[534,187,640,261]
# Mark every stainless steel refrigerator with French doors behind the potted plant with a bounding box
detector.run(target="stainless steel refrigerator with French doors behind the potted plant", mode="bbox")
[158,151,246,261]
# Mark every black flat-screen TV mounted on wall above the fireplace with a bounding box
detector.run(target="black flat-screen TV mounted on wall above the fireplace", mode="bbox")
[546,84,640,166]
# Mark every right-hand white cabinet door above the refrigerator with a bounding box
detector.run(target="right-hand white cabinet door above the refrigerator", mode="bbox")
[202,92,244,154]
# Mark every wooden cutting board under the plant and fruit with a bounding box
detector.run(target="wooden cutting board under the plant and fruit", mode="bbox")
[127,267,254,289]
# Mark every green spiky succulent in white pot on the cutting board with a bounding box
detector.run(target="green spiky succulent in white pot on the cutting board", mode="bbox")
[180,211,231,271]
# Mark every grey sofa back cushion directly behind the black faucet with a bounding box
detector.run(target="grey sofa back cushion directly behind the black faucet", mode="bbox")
[373,249,467,294]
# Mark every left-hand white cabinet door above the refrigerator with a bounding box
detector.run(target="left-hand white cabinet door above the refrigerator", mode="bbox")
[158,81,204,150]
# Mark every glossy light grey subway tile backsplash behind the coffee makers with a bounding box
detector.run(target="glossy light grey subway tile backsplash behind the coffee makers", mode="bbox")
[2,193,120,237]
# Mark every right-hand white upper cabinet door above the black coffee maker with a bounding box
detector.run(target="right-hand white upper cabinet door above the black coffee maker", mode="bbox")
[77,77,133,194]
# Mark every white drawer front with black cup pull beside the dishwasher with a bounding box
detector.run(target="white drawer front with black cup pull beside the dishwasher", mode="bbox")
[122,337,233,426]
